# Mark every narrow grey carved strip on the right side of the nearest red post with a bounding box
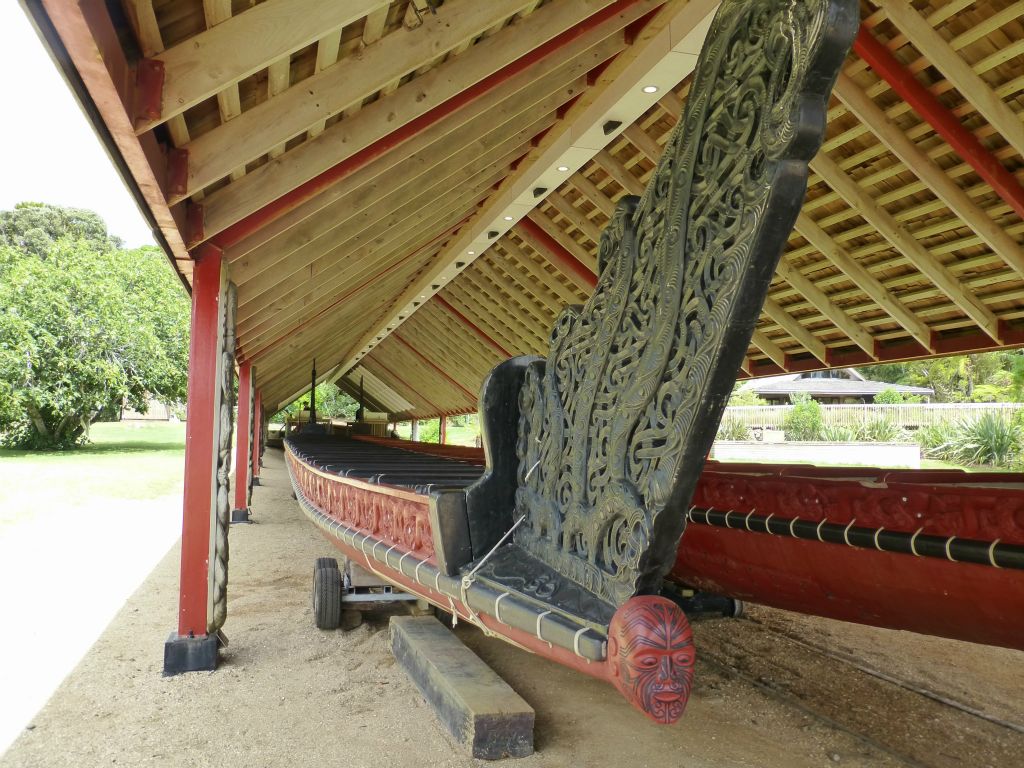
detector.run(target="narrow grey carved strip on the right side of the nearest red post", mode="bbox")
[207,281,237,635]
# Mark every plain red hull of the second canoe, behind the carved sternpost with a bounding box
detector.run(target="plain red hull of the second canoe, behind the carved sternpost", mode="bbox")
[354,440,1024,650]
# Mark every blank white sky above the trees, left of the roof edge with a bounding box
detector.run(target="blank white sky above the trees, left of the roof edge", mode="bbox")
[0,0,153,247]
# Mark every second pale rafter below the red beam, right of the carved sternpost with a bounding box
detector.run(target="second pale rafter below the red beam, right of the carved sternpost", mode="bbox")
[811,154,1000,341]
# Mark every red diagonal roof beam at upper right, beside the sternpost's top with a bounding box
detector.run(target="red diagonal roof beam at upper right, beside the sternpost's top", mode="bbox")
[853,25,1024,218]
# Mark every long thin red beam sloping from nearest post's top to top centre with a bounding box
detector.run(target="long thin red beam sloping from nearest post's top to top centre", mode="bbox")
[215,0,651,249]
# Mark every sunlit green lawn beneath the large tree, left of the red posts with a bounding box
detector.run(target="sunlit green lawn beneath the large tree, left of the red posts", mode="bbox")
[0,423,185,524]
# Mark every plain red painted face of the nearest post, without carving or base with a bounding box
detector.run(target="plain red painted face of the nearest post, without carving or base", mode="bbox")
[178,246,222,637]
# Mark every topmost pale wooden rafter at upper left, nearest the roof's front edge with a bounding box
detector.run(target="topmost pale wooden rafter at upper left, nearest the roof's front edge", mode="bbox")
[137,0,390,132]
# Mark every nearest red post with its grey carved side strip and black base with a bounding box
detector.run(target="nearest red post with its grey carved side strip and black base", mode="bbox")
[164,246,236,675]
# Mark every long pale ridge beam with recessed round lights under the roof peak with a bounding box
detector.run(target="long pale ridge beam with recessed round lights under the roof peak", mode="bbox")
[331,0,718,378]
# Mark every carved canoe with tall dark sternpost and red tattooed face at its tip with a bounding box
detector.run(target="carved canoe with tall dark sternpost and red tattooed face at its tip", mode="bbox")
[288,0,859,723]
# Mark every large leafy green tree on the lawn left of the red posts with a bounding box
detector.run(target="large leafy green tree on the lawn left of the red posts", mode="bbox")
[0,206,188,447]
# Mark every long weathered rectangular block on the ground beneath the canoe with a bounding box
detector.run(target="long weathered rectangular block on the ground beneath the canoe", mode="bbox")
[391,616,534,760]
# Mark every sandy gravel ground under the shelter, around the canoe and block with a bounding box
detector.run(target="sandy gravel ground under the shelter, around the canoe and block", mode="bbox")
[0,453,1024,768]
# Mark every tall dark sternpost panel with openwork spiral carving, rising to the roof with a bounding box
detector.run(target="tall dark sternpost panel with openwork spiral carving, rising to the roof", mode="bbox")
[515,0,859,605]
